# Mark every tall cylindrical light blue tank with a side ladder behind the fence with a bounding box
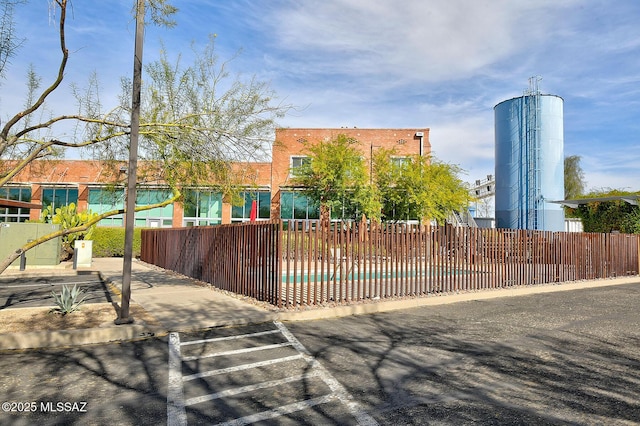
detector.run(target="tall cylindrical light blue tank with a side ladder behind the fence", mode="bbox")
[494,88,564,231]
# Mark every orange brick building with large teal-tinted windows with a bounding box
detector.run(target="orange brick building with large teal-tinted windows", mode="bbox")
[0,128,431,227]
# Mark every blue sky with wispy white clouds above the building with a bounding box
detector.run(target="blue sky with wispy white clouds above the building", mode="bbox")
[0,0,640,191]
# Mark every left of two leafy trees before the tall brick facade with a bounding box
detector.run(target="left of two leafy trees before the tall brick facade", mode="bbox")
[291,134,380,223]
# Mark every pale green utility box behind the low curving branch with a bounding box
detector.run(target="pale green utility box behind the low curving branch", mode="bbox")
[0,222,62,267]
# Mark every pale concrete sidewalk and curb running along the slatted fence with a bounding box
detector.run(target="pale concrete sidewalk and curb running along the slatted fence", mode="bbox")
[0,258,640,350]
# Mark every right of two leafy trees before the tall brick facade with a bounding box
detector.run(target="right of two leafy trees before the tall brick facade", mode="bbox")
[373,149,471,223]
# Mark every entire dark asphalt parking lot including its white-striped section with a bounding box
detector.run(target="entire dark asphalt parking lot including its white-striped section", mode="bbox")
[0,282,640,426]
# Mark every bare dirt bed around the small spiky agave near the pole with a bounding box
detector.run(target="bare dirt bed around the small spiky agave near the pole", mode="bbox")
[0,303,160,334]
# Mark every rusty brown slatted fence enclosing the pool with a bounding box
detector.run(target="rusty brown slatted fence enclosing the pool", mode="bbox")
[142,221,640,308]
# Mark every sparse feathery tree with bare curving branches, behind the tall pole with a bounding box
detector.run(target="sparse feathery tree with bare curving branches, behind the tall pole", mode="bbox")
[0,0,290,273]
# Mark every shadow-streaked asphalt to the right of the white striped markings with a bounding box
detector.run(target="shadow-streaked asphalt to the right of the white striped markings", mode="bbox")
[287,283,640,426]
